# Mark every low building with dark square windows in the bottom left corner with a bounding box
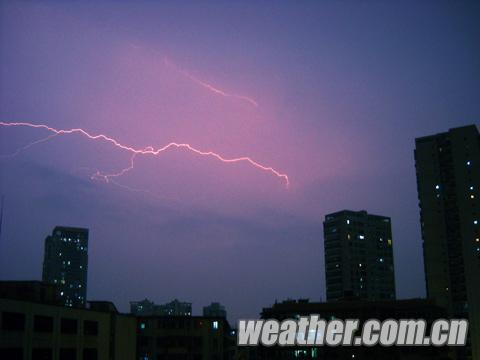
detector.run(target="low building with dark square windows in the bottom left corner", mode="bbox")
[0,298,136,360]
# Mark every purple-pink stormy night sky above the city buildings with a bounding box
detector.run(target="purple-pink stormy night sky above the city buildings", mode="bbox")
[0,1,480,320]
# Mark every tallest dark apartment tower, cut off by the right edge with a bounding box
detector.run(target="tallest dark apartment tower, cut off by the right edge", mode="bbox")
[415,125,480,359]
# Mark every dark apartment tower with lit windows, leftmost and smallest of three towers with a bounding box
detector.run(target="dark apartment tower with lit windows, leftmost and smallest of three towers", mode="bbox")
[42,226,88,307]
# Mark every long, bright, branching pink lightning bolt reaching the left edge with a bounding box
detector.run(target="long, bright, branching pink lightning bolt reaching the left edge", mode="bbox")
[0,121,290,187]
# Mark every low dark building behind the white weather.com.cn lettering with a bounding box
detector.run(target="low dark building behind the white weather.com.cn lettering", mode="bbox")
[256,299,452,360]
